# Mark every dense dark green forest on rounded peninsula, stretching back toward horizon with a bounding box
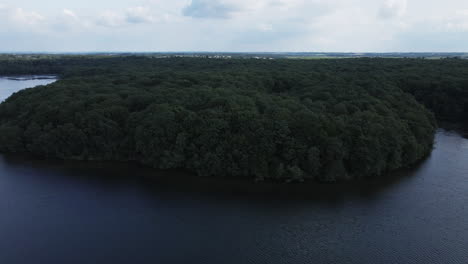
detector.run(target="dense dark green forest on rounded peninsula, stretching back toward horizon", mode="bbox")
[0,56,468,182]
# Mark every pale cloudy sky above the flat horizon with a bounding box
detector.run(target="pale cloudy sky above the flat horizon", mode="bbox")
[0,0,468,52]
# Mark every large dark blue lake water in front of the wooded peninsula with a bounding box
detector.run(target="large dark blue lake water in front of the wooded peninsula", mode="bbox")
[0,79,468,264]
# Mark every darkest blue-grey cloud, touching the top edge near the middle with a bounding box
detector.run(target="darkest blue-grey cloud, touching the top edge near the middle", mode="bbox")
[182,0,238,18]
